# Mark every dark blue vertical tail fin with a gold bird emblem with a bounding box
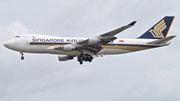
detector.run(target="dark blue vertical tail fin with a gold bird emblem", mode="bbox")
[139,16,174,39]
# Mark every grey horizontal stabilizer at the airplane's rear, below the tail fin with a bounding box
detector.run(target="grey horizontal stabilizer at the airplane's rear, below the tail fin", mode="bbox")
[147,35,176,44]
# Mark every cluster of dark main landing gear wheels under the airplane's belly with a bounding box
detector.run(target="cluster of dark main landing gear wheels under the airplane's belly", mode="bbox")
[77,54,93,64]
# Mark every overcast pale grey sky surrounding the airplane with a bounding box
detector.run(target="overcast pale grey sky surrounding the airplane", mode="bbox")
[0,0,180,101]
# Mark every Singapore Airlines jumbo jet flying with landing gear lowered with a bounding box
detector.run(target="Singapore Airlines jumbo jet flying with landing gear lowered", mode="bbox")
[4,16,176,64]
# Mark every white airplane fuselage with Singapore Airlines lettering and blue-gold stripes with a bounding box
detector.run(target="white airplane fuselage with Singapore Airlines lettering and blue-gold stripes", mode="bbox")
[4,34,165,56]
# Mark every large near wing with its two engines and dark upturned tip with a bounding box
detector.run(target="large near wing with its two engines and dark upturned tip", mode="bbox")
[54,21,136,54]
